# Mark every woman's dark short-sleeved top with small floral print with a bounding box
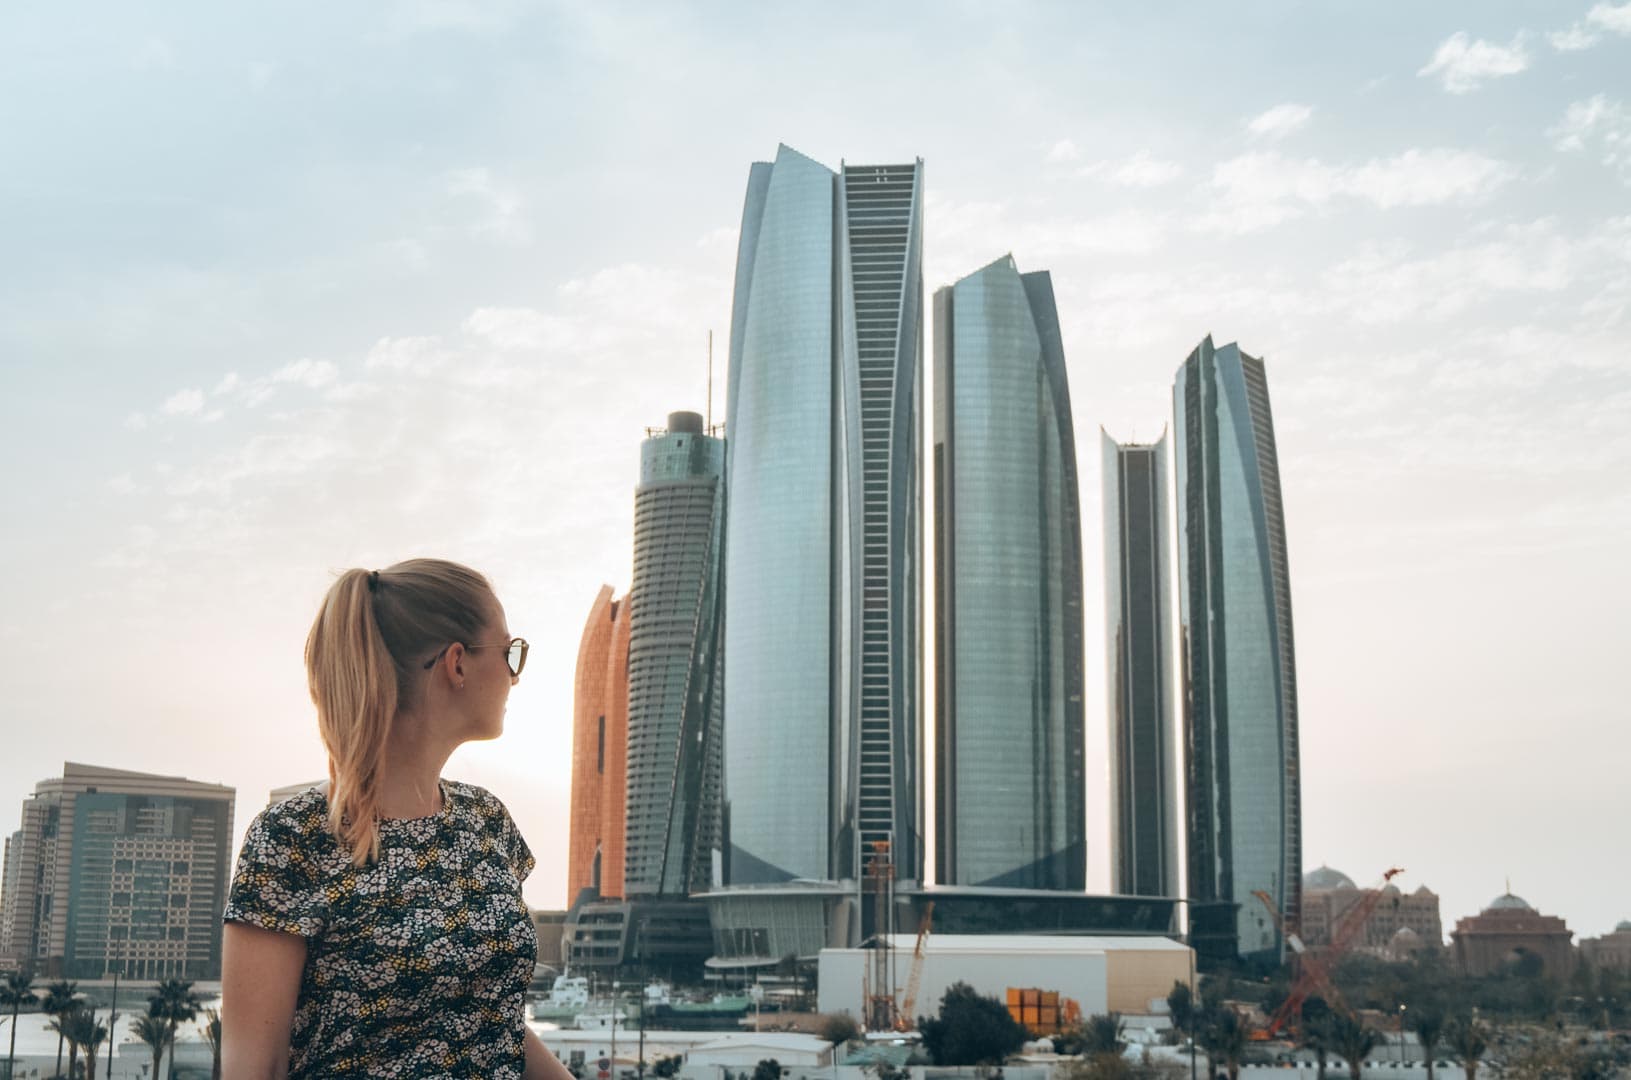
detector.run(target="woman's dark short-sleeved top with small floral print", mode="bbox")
[225,780,538,1080]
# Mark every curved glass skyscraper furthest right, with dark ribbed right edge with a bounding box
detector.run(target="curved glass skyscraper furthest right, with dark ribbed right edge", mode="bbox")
[1173,336,1303,964]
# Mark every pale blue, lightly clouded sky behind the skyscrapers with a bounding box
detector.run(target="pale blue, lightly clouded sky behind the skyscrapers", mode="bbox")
[0,0,1631,936]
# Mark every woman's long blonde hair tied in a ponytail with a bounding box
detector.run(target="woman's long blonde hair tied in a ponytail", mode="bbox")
[305,558,497,866]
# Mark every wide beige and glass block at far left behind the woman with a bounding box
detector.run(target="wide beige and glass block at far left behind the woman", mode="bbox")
[0,762,236,980]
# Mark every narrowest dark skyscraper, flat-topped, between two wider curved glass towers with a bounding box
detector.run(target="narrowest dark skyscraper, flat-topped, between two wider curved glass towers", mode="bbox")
[1103,432,1179,896]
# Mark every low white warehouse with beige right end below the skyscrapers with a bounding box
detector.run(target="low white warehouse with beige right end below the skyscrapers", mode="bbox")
[817,933,1194,1018]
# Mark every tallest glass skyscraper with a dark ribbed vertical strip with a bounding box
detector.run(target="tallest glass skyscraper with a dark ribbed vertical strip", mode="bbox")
[724,147,923,884]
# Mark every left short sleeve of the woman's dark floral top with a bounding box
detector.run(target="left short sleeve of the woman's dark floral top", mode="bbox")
[222,806,328,938]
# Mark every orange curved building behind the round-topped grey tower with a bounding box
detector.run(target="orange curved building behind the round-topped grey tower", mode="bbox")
[566,586,630,904]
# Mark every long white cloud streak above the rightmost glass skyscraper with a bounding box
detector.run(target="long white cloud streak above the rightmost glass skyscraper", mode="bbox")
[1196,148,1514,233]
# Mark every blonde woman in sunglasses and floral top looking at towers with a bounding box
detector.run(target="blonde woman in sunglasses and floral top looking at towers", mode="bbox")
[222,560,571,1080]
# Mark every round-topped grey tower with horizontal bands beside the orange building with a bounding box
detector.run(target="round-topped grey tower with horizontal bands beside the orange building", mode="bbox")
[625,413,724,897]
